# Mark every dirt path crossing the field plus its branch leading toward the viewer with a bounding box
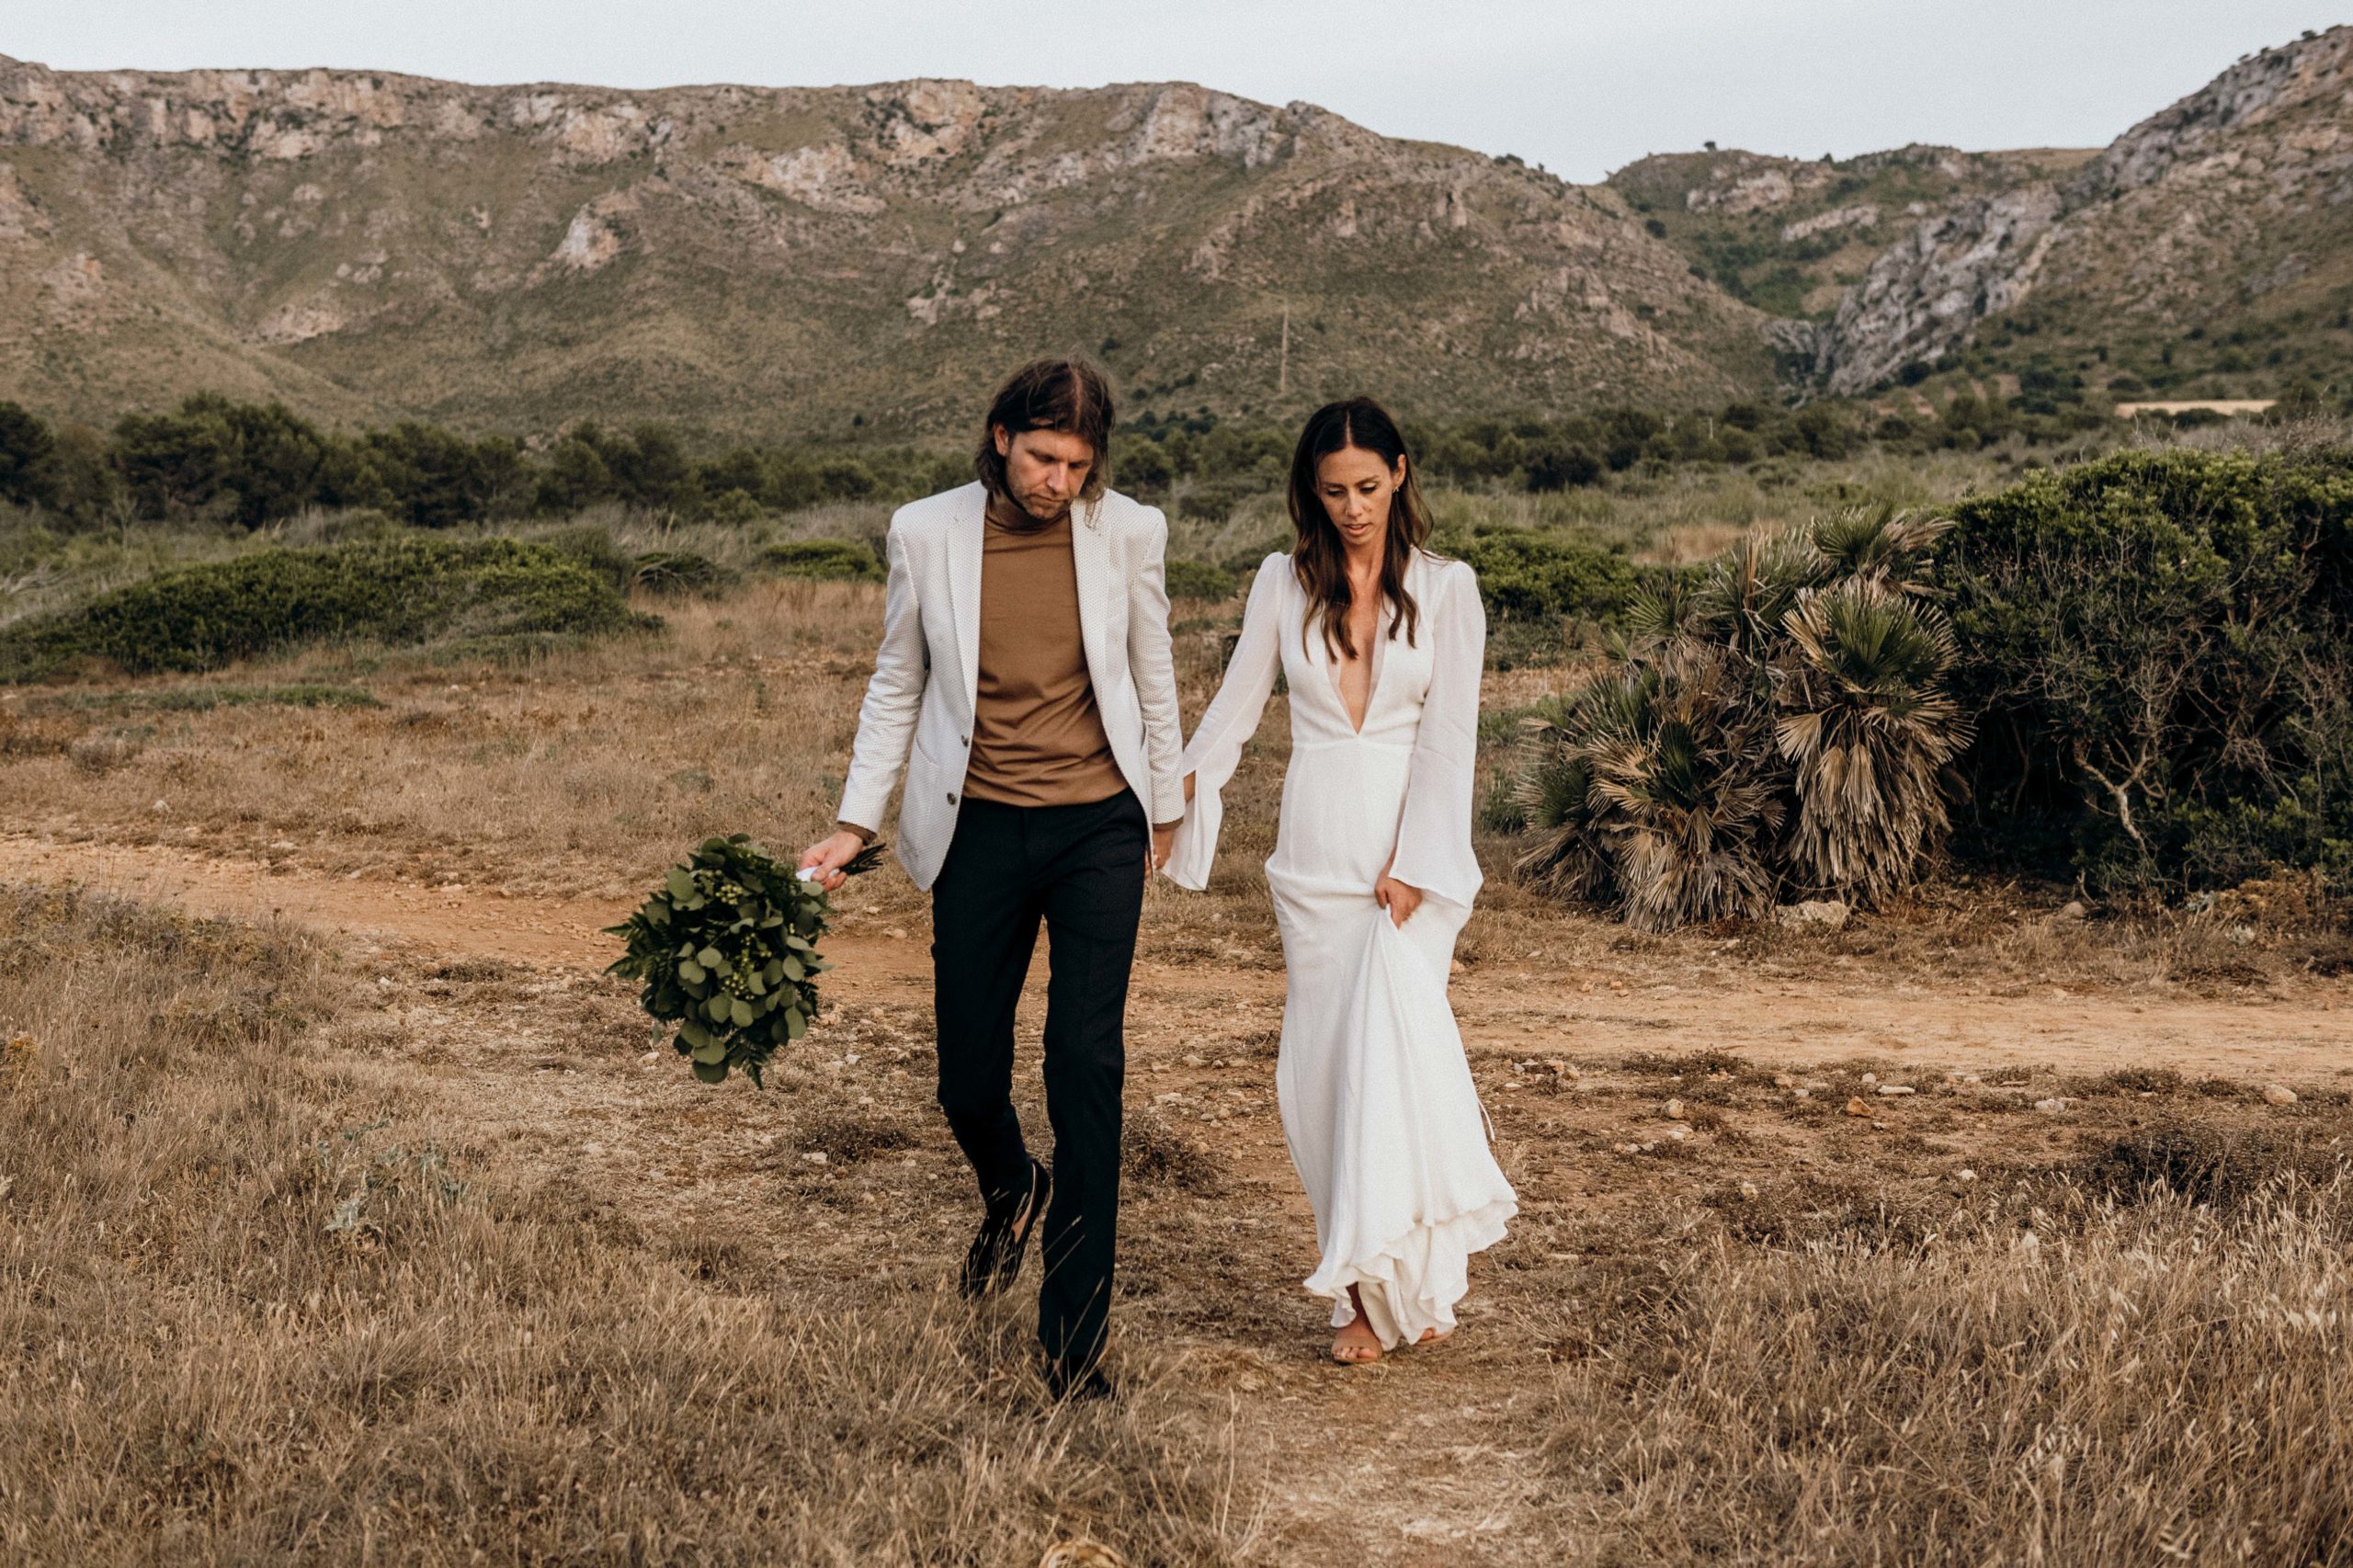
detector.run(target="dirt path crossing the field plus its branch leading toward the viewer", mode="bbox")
[0,834,2353,1565]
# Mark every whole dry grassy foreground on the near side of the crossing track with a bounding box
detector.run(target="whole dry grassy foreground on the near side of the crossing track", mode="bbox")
[0,866,2353,1565]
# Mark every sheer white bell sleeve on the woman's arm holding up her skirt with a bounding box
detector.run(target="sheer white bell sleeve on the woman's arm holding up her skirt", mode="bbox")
[1388,561,1487,909]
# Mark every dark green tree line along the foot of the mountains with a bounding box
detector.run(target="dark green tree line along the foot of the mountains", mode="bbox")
[0,384,2183,529]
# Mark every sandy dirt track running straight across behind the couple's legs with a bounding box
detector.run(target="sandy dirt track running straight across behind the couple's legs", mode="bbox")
[0,834,2353,1081]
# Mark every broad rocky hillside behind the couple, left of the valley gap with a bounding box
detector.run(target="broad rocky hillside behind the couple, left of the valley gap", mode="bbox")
[0,59,1772,436]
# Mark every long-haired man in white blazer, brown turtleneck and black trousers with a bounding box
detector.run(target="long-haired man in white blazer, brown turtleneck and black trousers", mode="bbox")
[800,360,1184,1399]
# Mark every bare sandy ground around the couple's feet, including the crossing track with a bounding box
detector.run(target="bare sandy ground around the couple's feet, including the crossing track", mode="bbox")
[0,834,2353,1563]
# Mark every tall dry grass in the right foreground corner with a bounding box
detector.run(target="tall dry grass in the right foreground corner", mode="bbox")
[1551,1177,2353,1565]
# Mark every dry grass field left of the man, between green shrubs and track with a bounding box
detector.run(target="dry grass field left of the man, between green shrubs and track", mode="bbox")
[5,582,898,897]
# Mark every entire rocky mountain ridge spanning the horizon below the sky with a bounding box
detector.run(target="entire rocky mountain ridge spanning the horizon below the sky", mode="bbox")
[0,28,2353,437]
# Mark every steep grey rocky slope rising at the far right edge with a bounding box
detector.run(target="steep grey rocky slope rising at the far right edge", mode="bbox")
[1812,26,2353,395]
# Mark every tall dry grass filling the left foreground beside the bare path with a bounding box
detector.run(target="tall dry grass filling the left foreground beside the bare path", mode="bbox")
[0,890,1256,1563]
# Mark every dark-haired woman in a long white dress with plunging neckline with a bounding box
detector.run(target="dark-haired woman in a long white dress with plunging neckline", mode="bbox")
[1169,398,1518,1363]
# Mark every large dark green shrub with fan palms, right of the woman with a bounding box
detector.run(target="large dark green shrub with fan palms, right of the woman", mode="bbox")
[1495,449,2353,927]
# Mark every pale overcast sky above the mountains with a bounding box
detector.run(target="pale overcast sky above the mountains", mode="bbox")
[0,0,2353,181]
